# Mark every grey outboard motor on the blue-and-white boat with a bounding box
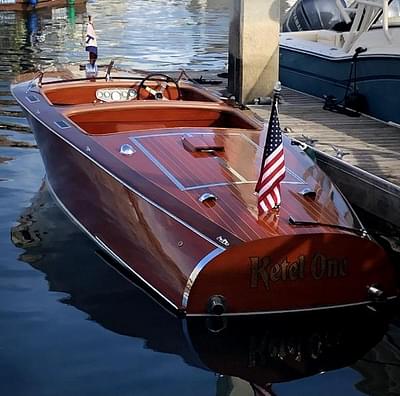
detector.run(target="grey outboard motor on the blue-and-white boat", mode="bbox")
[282,0,350,32]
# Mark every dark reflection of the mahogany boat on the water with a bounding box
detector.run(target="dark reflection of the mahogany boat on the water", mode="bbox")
[11,184,387,395]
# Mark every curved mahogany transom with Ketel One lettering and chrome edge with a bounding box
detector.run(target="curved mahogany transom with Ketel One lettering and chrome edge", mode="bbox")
[183,233,397,315]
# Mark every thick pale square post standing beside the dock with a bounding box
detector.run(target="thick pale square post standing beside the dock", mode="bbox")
[228,0,280,103]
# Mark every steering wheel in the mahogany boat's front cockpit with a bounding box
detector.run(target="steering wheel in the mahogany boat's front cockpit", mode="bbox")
[137,73,182,100]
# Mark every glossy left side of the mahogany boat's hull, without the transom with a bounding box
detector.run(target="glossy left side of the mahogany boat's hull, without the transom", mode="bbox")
[31,114,218,309]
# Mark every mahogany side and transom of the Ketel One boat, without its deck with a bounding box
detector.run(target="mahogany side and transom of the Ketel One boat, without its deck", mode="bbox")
[23,112,395,315]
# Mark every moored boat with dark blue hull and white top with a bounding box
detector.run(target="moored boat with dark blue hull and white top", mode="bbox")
[280,0,400,125]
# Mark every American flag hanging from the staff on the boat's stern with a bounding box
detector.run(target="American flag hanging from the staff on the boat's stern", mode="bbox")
[256,95,286,217]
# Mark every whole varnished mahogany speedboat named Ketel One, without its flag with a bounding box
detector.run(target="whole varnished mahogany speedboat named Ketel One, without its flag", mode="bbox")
[12,67,397,316]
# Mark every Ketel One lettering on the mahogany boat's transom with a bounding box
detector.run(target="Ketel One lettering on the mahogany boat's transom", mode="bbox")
[250,253,348,290]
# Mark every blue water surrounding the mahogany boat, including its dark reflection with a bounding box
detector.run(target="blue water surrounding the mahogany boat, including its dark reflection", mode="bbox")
[0,0,400,396]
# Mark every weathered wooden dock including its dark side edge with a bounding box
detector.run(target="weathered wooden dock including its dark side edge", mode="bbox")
[250,88,400,227]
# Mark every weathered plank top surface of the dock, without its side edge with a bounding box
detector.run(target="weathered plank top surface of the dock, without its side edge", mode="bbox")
[250,87,400,186]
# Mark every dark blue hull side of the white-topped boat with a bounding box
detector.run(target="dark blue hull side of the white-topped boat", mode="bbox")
[280,46,400,124]
